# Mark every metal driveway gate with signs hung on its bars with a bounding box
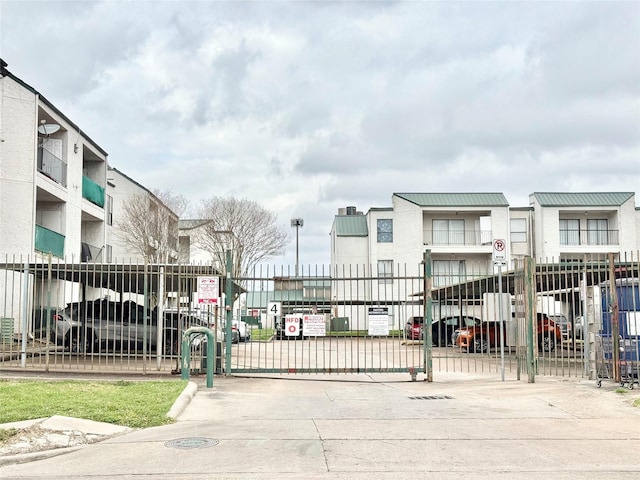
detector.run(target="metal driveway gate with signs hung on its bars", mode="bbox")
[229,267,425,379]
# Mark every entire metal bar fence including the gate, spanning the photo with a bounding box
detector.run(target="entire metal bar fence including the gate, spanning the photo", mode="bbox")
[0,253,640,381]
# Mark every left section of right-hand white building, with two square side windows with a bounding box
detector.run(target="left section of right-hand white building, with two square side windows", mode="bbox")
[331,193,509,282]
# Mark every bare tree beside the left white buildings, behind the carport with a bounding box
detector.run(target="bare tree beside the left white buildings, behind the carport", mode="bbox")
[115,192,178,263]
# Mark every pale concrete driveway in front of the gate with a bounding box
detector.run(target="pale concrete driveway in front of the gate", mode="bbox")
[0,373,640,480]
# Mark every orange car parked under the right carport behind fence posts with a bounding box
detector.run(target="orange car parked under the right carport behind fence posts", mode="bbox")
[455,313,562,353]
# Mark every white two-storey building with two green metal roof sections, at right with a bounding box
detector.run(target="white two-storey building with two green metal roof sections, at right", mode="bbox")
[330,192,640,285]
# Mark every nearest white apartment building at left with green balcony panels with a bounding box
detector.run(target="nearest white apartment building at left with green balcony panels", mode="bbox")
[0,60,108,261]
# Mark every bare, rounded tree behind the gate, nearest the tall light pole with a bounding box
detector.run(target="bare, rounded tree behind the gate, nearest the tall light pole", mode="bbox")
[196,197,290,278]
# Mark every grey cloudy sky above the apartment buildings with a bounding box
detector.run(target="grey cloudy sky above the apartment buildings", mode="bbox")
[0,0,640,268]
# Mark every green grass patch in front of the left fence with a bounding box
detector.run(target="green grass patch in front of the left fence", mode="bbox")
[0,380,187,430]
